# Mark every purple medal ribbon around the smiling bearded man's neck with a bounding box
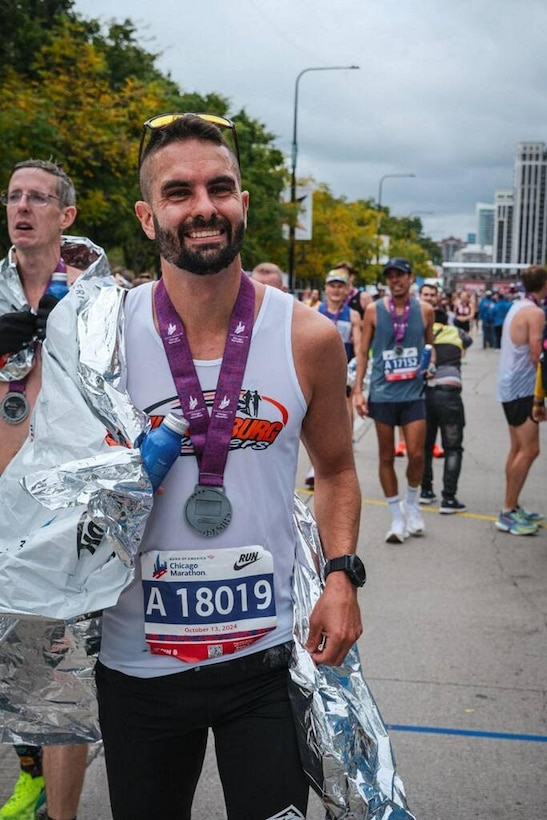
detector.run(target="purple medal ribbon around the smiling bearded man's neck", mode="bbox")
[154,271,255,487]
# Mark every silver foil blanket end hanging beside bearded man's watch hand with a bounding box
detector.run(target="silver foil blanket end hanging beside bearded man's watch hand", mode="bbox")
[289,497,414,820]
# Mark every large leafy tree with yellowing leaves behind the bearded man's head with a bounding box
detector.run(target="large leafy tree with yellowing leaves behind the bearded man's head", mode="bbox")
[0,8,285,271]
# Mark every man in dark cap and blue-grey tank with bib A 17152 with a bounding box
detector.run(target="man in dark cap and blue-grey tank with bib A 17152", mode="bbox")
[354,257,435,544]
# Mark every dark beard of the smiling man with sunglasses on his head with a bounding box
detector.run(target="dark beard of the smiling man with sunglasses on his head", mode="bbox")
[153,216,245,276]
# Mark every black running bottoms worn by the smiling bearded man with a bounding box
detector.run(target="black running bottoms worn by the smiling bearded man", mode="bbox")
[95,644,308,820]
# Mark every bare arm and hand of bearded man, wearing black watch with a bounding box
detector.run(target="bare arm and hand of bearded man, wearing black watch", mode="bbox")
[293,302,362,666]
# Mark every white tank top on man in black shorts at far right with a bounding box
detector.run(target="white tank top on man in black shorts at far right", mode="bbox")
[498,299,536,402]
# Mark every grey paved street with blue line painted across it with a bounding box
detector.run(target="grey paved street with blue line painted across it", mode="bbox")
[0,338,547,820]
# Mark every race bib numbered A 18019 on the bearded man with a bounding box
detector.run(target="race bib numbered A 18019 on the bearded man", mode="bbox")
[141,545,277,662]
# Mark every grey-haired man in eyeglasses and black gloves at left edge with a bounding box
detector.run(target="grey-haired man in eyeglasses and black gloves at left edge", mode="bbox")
[0,160,104,820]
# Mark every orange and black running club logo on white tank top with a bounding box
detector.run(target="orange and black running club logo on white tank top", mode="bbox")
[146,387,289,456]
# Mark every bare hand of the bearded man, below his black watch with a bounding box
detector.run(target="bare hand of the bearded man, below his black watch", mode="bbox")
[305,572,363,666]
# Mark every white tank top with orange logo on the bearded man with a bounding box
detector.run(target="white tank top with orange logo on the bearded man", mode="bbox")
[100,278,307,678]
